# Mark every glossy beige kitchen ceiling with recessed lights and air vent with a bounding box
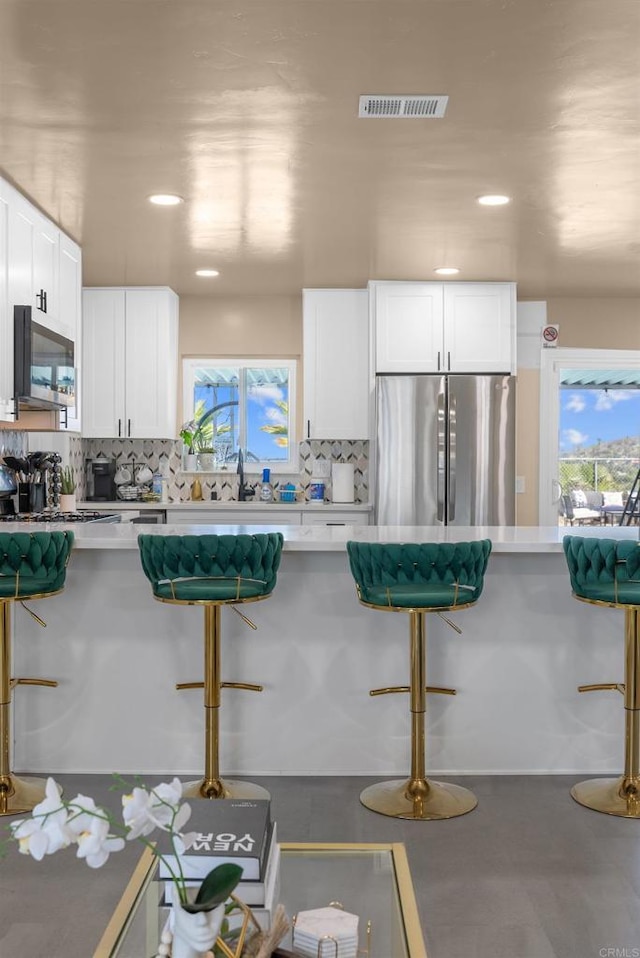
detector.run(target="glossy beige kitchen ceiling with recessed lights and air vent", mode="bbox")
[0,0,640,299]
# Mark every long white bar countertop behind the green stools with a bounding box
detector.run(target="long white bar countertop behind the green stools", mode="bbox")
[3,522,640,554]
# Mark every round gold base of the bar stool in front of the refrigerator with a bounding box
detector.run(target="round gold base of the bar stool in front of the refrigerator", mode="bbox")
[360,779,478,821]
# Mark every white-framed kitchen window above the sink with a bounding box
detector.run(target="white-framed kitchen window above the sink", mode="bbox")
[183,358,298,472]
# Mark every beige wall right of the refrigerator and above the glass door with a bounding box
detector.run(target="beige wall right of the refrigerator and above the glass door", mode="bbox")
[516,297,640,526]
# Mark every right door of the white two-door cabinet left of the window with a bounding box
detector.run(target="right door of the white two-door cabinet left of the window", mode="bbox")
[124,289,178,439]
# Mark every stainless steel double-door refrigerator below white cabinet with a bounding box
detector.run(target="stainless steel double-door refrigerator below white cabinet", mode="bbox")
[375,375,515,526]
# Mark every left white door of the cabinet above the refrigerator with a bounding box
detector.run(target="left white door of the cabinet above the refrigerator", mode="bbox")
[369,283,444,373]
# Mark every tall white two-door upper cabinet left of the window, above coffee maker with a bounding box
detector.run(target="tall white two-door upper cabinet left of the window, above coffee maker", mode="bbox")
[82,287,178,439]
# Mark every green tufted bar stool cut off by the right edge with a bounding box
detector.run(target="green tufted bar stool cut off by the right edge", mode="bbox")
[562,536,640,818]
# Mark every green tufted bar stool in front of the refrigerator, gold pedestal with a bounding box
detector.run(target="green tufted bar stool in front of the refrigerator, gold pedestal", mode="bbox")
[347,539,491,820]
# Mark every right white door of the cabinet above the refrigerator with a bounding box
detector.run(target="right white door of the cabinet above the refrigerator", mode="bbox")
[444,283,516,373]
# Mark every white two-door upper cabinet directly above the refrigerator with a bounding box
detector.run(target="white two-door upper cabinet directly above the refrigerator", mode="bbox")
[369,282,516,373]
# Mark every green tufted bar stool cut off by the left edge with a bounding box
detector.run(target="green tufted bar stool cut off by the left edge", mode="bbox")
[0,532,73,815]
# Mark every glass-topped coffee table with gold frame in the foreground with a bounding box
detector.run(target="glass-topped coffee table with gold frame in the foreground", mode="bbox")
[94,842,427,958]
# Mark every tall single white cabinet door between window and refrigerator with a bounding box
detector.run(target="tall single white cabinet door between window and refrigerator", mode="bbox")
[303,289,370,439]
